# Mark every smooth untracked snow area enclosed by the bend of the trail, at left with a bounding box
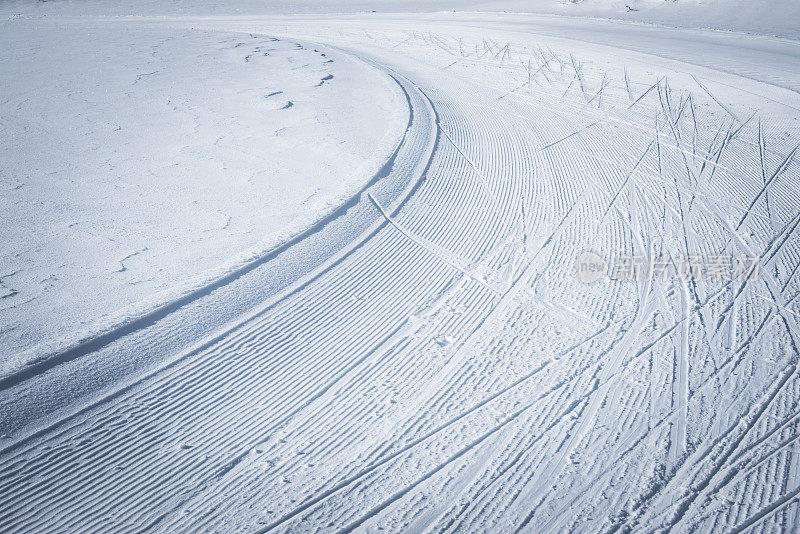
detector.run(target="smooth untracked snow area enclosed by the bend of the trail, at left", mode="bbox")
[0,19,408,375]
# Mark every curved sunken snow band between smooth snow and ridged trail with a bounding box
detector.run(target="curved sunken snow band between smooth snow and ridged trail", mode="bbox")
[0,58,439,448]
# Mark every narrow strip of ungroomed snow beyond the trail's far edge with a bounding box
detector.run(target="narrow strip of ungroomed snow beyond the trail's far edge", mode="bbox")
[0,0,800,39]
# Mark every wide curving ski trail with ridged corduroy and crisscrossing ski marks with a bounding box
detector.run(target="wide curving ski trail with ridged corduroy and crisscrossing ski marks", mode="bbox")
[0,14,800,533]
